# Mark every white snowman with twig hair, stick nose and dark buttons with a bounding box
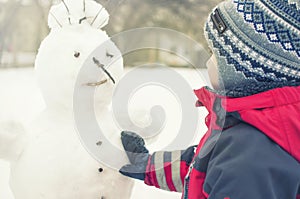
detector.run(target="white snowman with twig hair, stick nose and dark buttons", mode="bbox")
[0,0,133,199]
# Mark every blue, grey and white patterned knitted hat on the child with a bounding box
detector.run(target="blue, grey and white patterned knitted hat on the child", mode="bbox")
[205,0,300,97]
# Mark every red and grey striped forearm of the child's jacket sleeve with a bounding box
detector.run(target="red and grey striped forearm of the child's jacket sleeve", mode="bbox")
[144,146,195,192]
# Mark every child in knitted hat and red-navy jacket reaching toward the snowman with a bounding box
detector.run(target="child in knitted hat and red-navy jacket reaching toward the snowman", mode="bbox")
[120,0,300,199]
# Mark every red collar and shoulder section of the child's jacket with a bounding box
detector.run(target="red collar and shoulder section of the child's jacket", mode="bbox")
[194,86,300,161]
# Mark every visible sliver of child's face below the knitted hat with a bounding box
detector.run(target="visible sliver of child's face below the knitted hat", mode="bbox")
[206,54,219,89]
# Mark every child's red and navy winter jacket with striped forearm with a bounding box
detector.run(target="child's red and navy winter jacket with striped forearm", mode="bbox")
[145,87,300,199]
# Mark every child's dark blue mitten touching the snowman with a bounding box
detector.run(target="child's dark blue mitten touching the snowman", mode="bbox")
[119,131,150,180]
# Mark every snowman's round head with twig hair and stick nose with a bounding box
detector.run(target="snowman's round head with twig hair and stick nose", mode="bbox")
[35,0,123,109]
